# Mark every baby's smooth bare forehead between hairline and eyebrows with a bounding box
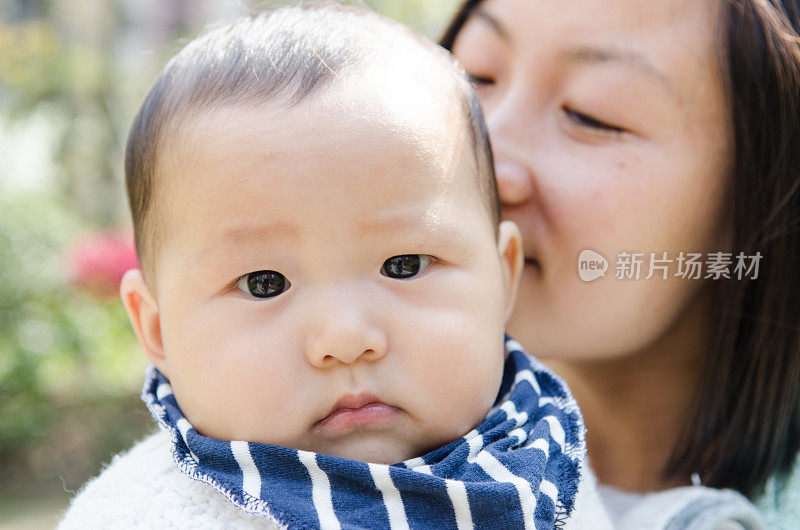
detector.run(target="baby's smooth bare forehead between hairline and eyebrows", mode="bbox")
[152,97,491,268]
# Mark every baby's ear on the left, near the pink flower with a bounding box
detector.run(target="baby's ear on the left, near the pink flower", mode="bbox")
[119,269,169,377]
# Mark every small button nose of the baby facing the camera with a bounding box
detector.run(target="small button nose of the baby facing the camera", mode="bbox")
[306,301,387,368]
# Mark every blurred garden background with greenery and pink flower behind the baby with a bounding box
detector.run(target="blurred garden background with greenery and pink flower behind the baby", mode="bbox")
[0,0,457,530]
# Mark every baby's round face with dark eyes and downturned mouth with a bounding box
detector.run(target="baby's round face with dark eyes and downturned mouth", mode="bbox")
[131,78,519,463]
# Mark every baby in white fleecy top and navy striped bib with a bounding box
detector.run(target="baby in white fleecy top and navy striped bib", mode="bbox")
[54,4,585,529]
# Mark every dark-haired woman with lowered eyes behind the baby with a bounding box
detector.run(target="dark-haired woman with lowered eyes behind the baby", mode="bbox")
[442,0,800,528]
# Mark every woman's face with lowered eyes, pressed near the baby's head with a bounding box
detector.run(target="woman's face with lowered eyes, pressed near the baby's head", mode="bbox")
[453,0,733,359]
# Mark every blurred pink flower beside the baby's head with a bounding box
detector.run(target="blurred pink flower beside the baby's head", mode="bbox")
[67,230,139,296]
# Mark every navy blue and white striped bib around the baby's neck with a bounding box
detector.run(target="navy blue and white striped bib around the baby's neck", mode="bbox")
[142,338,586,530]
